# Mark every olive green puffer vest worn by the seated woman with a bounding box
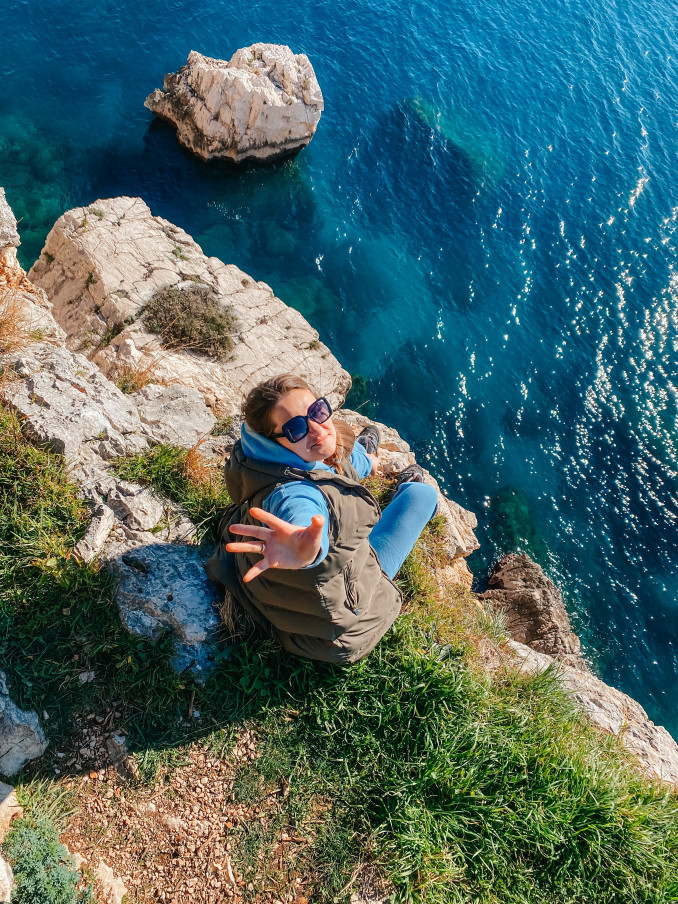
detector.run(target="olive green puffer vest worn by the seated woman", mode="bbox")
[212,442,402,663]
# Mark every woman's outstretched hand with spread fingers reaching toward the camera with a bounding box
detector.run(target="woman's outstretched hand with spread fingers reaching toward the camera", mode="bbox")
[226,508,325,583]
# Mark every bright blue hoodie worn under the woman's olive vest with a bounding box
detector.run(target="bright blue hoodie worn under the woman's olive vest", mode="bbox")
[240,424,372,568]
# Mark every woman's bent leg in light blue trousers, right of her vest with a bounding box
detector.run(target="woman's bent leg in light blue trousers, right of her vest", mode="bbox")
[370,483,438,578]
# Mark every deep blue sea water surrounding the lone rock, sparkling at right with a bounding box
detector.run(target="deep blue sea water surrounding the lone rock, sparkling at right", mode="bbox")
[0,0,678,736]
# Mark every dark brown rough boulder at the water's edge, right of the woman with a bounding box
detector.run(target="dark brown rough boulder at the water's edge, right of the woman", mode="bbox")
[480,553,581,656]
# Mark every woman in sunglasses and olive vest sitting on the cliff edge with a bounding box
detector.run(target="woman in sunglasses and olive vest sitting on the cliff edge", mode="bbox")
[207,374,437,663]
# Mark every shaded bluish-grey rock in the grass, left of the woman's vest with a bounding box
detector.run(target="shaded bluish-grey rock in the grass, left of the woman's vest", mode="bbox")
[110,543,219,673]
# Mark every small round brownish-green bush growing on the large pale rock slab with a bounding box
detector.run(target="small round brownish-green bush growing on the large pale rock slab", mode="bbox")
[144,283,235,360]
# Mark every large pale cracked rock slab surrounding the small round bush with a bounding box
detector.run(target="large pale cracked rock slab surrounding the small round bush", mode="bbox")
[29,198,351,414]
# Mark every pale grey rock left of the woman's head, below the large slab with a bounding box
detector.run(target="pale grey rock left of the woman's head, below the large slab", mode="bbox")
[130,383,217,449]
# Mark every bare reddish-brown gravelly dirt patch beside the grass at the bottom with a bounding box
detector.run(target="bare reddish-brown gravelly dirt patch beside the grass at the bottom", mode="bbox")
[62,731,312,904]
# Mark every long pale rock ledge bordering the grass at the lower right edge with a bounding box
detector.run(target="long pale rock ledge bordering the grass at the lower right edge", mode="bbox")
[507,641,678,790]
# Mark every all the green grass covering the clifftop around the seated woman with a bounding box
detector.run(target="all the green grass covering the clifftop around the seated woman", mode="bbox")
[0,412,678,904]
